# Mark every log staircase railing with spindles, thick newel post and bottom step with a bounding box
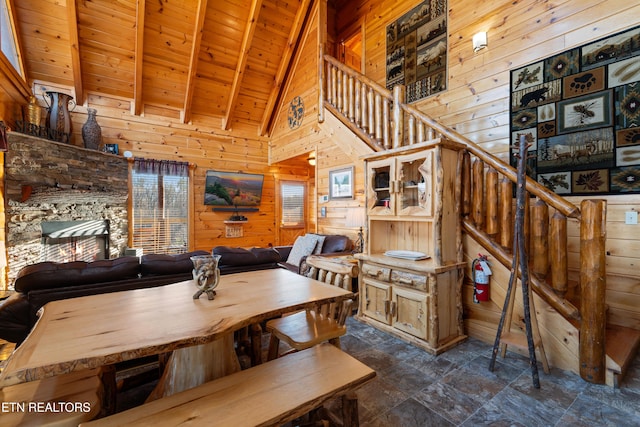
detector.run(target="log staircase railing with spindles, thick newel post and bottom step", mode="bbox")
[319,55,640,387]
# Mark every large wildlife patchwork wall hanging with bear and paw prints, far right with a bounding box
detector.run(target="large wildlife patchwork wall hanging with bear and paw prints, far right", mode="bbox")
[510,27,640,195]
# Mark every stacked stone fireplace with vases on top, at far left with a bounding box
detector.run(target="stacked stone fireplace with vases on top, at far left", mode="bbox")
[4,132,128,288]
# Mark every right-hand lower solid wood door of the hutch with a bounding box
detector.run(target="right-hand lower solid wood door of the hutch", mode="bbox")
[391,287,429,339]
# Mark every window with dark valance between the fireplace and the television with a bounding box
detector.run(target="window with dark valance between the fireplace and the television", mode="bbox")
[132,159,189,254]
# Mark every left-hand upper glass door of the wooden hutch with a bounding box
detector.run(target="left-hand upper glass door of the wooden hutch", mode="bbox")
[367,158,396,215]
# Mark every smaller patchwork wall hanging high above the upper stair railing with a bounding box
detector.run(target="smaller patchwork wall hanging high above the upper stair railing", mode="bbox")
[387,0,447,102]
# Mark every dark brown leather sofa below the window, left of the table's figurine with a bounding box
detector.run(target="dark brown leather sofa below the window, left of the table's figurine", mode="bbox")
[0,251,209,343]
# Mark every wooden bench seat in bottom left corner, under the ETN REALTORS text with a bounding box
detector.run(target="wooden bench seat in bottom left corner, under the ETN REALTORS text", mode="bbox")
[0,367,115,427]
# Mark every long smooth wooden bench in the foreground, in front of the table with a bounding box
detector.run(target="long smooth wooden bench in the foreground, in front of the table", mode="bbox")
[81,344,376,427]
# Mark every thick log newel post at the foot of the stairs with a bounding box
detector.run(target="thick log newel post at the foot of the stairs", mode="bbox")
[580,200,607,384]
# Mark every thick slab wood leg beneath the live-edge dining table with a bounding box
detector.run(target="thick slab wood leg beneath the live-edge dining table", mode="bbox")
[147,333,240,402]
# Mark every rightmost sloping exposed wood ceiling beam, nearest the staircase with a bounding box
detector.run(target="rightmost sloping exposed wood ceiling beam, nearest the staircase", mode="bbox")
[258,0,312,136]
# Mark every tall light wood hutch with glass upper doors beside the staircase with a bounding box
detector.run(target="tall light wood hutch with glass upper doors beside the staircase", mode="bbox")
[357,140,466,354]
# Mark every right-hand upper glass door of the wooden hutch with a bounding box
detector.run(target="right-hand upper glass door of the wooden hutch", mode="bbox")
[395,150,435,217]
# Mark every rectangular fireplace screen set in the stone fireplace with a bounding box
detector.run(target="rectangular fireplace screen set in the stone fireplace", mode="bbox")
[40,220,109,262]
